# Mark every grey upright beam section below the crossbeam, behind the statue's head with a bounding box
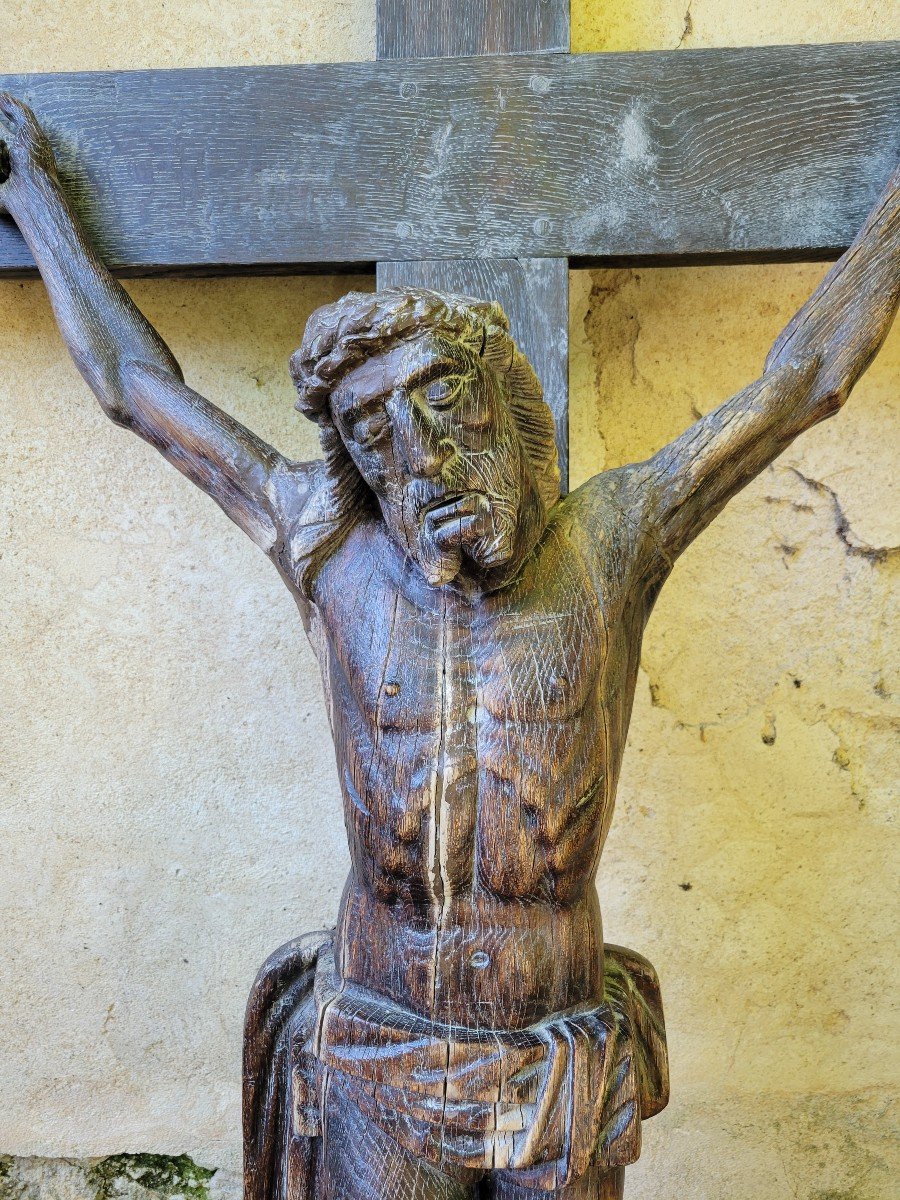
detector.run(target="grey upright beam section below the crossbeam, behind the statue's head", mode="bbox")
[378,258,569,491]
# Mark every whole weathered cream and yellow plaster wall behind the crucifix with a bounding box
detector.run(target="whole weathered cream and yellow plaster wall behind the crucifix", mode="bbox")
[0,0,900,1200]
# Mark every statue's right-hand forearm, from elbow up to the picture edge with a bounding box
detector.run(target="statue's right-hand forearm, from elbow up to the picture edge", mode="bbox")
[766,157,900,424]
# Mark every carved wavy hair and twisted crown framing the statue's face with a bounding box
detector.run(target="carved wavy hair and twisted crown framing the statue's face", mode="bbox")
[290,288,559,592]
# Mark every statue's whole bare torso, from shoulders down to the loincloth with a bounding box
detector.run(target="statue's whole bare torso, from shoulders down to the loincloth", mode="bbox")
[289,472,662,1027]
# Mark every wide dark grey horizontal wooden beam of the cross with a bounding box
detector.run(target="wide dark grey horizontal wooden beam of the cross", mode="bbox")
[0,42,900,274]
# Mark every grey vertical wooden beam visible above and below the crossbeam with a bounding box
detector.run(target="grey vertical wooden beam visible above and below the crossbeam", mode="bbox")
[377,0,569,491]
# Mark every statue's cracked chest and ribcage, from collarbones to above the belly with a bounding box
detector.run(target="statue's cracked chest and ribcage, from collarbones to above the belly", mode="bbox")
[317,520,628,902]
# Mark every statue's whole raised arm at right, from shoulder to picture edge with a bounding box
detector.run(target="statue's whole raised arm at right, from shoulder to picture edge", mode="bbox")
[635,168,900,563]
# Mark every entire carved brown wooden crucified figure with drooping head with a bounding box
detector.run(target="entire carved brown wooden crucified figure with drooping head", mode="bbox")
[0,97,900,1200]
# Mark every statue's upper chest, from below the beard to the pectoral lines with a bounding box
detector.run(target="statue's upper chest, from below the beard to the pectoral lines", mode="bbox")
[319,525,606,743]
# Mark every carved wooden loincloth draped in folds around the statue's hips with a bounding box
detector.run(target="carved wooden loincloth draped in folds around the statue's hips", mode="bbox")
[245,940,668,1200]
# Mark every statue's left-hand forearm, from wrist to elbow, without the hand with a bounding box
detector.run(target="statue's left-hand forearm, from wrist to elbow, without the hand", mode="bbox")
[7,162,181,425]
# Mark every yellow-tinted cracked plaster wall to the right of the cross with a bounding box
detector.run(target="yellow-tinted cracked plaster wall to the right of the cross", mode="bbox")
[571,0,900,1200]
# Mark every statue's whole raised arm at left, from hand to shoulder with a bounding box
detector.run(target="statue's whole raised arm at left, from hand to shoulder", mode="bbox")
[0,95,306,551]
